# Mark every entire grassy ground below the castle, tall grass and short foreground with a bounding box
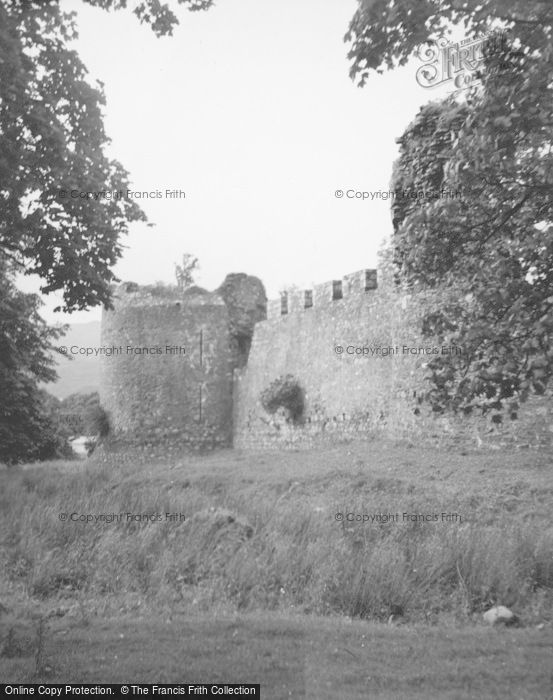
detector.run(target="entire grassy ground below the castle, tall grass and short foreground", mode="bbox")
[0,443,553,700]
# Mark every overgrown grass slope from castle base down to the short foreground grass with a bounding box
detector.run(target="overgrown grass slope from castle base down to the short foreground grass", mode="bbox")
[0,445,553,623]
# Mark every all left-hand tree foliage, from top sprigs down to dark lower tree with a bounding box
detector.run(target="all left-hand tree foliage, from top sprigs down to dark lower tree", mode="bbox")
[0,0,212,463]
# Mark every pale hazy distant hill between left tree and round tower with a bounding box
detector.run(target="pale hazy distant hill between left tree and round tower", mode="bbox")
[44,321,100,399]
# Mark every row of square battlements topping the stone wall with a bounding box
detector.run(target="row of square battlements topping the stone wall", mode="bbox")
[267,270,378,319]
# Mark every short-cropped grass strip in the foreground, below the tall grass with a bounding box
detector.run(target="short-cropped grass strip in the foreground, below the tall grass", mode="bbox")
[0,613,553,700]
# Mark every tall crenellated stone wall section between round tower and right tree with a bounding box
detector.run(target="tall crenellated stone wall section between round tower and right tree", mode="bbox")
[235,271,416,447]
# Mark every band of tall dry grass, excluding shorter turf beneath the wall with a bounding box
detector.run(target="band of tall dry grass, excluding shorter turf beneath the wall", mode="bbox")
[0,454,553,621]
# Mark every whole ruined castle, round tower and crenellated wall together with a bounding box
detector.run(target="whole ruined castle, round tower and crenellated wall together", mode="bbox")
[101,270,553,449]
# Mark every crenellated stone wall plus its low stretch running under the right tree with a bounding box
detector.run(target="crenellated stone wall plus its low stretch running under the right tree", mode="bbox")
[234,270,553,449]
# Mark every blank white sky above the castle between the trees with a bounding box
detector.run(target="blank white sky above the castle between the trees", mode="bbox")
[18,0,458,323]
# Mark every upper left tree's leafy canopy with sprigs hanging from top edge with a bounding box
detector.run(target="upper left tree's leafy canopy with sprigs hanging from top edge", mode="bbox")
[0,0,212,311]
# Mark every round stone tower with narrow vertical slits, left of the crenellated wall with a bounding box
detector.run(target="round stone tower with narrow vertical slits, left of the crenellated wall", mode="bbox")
[100,285,234,447]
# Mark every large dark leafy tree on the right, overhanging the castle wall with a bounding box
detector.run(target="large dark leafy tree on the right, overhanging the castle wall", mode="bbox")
[348,0,553,421]
